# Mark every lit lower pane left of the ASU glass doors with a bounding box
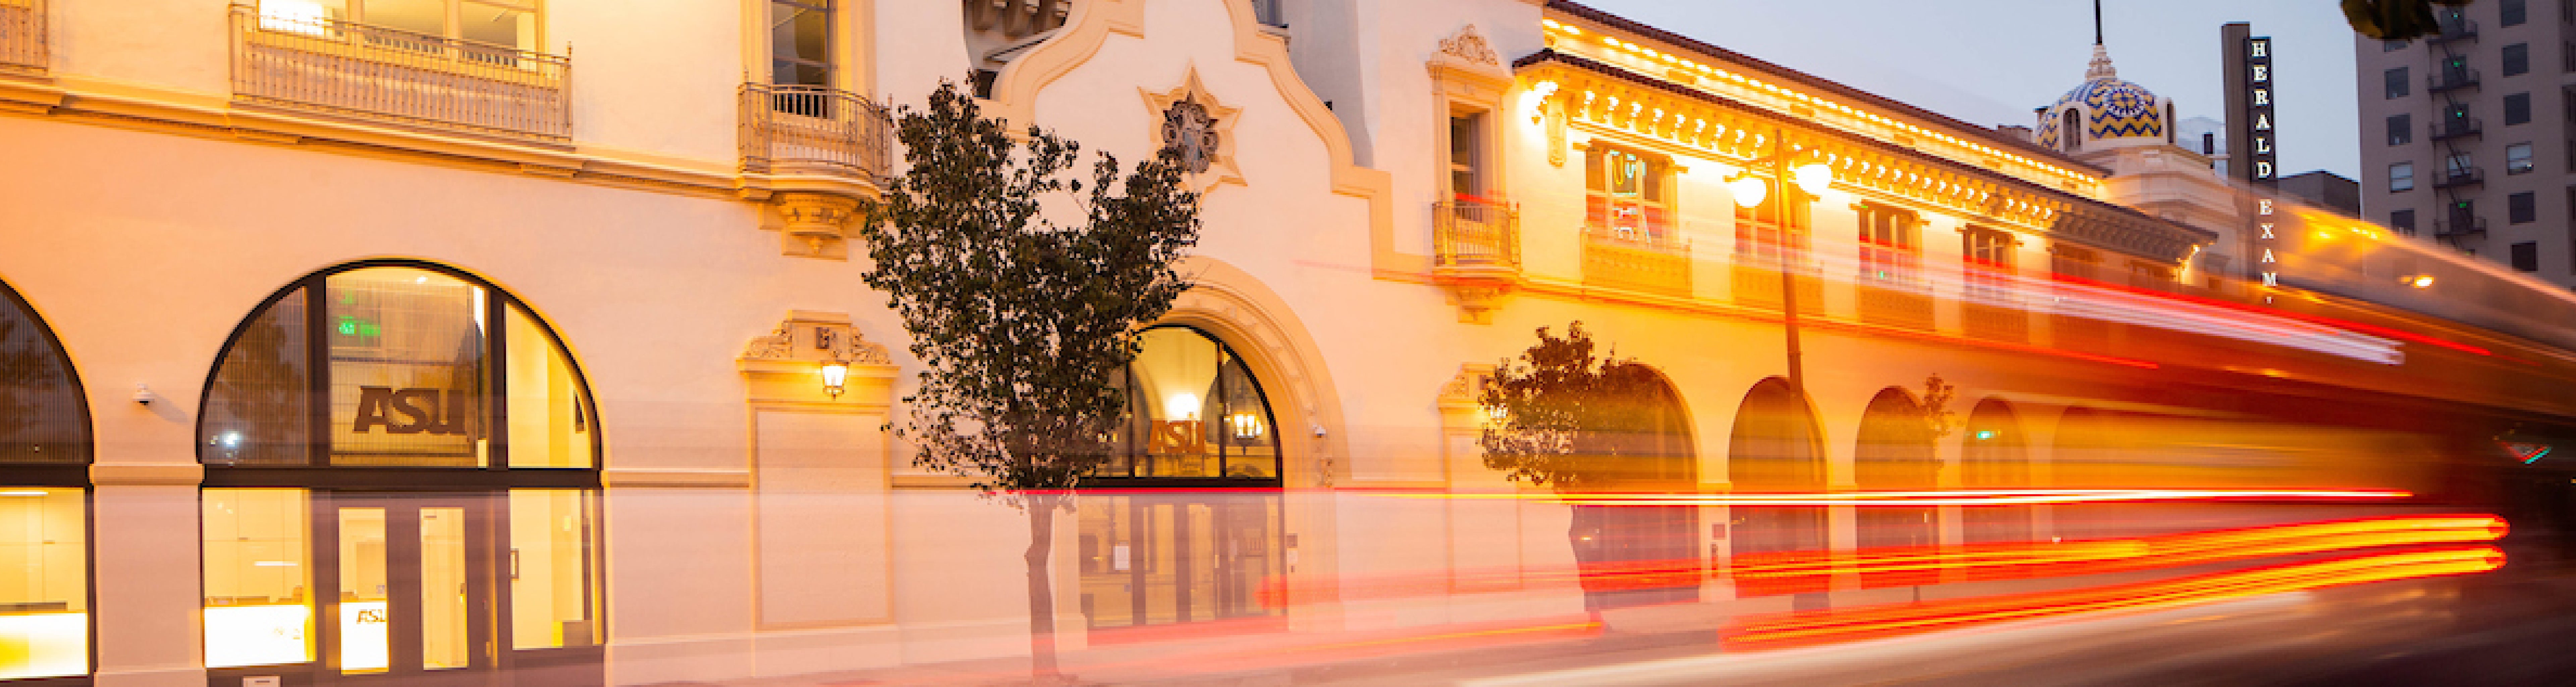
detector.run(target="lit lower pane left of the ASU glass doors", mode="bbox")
[204,489,314,669]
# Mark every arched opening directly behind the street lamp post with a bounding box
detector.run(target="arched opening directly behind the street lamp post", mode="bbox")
[1726,378,1826,594]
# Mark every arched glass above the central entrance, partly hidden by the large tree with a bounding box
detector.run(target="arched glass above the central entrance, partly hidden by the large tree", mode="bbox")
[1102,327,1280,481]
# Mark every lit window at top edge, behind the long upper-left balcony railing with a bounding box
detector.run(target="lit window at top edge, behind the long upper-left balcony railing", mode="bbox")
[260,0,538,51]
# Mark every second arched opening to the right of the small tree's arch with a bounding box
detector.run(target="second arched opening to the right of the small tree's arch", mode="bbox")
[1852,386,1940,587]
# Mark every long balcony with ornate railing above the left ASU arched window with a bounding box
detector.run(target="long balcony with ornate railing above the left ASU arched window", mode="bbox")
[229,0,572,141]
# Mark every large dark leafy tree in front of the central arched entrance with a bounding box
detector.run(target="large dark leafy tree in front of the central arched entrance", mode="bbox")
[860,82,1198,682]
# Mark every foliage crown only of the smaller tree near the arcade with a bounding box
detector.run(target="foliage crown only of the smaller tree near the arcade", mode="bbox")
[1479,322,1664,489]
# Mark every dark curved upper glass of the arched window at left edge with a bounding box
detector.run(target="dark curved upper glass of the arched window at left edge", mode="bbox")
[0,286,90,463]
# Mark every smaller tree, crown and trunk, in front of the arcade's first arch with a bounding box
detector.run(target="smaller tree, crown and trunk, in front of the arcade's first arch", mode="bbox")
[1479,322,1698,620]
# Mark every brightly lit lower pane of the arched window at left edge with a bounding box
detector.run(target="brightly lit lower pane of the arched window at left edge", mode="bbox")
[0,486,90,679]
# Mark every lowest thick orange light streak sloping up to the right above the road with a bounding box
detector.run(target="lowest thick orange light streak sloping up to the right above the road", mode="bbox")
[1721,546,2504,648]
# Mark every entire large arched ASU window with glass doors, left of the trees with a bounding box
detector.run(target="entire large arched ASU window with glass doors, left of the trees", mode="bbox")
[198,260,603,684]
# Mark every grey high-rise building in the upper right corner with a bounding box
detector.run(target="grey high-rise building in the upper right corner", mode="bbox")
[2354,0,2576,286]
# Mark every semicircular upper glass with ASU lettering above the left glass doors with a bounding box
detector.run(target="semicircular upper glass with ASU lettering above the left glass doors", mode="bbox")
[198,268,598,468]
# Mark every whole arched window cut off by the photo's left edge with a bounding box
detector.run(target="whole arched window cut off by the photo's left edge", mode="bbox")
[0,283,90,679]
